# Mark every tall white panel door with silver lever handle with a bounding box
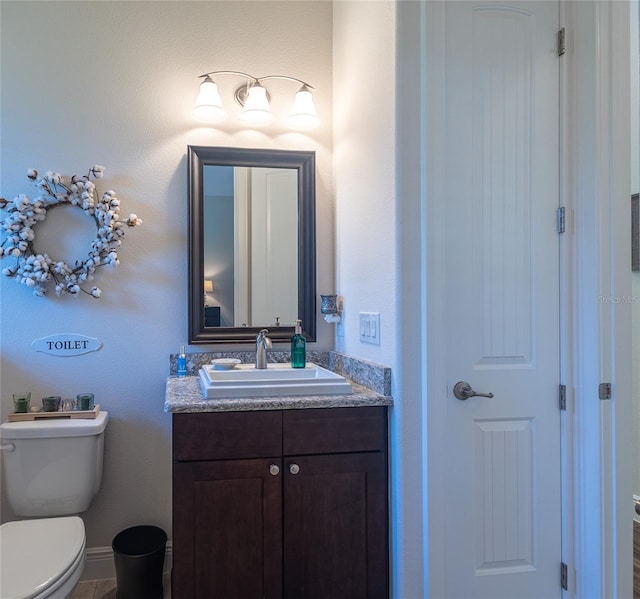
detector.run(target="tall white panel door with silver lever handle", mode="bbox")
[444,1,561,599]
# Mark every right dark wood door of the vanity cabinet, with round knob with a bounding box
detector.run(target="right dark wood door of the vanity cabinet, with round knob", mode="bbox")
[283,452,388,599]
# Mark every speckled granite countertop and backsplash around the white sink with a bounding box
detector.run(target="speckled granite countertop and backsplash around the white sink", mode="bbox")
[164,352,393,414]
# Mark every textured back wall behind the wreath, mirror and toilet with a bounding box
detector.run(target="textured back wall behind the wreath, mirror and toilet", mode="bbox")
[0,1,330,548]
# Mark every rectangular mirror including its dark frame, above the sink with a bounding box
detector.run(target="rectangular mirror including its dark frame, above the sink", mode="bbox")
[187,146,316,344]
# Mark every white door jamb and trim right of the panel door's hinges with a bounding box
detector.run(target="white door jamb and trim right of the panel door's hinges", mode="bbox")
[561,1,633,597]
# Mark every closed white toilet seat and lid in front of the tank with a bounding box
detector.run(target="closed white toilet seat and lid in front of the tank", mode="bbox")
[0,516,85,599]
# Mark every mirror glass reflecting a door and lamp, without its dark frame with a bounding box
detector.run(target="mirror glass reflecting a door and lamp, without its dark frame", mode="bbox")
[203,165,298,327]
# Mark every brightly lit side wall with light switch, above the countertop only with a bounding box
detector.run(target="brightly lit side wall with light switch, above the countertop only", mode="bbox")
[332,0,397,366]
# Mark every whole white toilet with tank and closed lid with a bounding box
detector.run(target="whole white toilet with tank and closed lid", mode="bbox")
[0,412,109,599]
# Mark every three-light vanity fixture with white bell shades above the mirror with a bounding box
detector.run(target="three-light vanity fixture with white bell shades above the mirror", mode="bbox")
[192,71,319,131]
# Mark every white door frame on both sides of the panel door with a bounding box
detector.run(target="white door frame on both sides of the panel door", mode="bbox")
[392,0,633,598]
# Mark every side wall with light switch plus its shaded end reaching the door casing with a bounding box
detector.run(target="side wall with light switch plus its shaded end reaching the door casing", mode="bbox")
[333,1,428,598]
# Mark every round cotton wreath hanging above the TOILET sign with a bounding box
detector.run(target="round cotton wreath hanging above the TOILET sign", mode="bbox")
[0,165,142,298]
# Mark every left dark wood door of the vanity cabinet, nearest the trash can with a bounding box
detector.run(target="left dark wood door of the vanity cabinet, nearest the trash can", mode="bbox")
[172,458,282,599]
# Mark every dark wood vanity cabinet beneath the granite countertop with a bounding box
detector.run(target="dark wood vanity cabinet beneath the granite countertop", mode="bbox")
[172,407,388,599]
